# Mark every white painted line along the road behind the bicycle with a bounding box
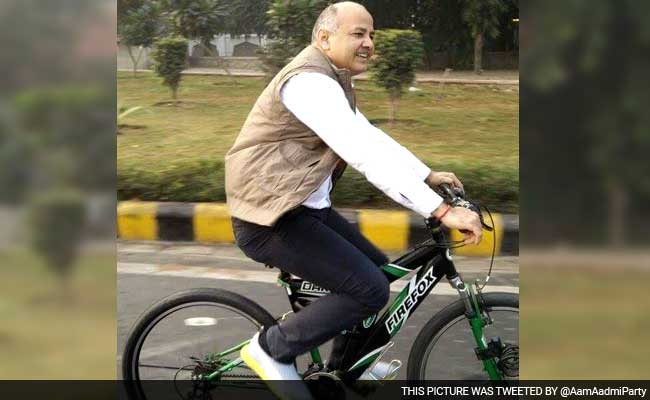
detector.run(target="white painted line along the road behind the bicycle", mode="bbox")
[117,262,519,296]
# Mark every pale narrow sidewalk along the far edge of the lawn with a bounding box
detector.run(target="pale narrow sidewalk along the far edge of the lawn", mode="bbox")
[118,68,519,86]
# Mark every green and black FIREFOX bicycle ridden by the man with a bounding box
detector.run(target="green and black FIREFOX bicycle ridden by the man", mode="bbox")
[122,185,519,398]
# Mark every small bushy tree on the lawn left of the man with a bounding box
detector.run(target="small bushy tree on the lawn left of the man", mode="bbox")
[152,37,188,100]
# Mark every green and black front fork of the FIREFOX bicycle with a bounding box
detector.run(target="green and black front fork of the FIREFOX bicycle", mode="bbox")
[449,274,503,380]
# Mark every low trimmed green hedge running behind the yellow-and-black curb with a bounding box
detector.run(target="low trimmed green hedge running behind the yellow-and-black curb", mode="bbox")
[117,160,519,213]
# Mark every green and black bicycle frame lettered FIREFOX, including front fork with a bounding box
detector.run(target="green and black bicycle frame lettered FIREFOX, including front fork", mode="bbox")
[278,220,503,380]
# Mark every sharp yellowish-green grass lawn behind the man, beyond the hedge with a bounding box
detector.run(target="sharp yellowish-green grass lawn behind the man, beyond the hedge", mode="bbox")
[117,72,519,211]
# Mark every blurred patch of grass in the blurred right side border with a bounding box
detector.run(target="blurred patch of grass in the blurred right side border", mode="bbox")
[520,265,650,380]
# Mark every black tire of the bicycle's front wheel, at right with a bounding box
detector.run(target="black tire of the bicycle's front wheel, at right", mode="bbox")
[406,293,519,381]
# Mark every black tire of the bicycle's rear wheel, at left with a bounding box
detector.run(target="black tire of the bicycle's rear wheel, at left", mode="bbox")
[122,288,276,399]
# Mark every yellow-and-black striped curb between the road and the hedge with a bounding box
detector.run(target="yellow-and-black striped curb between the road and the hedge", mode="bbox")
[117,201,519,256]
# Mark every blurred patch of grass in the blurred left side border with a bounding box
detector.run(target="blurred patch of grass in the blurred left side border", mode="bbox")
[0,250,117,379]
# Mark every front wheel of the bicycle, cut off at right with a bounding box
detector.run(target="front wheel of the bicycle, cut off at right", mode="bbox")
[407,293,519,380]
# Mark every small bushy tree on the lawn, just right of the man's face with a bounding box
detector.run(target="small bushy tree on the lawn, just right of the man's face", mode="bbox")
[370,29,424,123]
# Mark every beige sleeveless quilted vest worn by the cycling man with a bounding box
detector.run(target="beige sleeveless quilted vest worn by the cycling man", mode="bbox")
[226,46,356,226]
